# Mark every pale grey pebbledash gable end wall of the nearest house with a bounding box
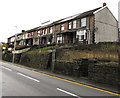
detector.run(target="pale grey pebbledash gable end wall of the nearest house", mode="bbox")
[94,7,119,43]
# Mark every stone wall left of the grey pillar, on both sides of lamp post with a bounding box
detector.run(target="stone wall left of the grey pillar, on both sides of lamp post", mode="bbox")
[2,52,51,69]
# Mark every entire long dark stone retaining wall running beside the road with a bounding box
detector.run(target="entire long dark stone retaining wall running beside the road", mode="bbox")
[3,47,120,86]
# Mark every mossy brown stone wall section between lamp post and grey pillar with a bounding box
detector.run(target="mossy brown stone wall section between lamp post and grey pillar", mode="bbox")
[19,53,51,69]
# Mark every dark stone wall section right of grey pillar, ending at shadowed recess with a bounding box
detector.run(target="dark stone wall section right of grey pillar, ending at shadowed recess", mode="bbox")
[54,59,88,77]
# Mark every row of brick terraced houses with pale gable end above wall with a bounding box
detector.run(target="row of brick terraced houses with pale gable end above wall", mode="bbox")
[8,6,119,46]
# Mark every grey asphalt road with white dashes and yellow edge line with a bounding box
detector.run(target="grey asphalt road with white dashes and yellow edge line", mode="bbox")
[0,62,117,98]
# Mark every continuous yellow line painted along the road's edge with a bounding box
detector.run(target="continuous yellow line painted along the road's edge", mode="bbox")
[4,65,120,96]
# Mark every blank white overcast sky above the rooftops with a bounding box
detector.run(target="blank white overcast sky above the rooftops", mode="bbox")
[0,0,120,42]
